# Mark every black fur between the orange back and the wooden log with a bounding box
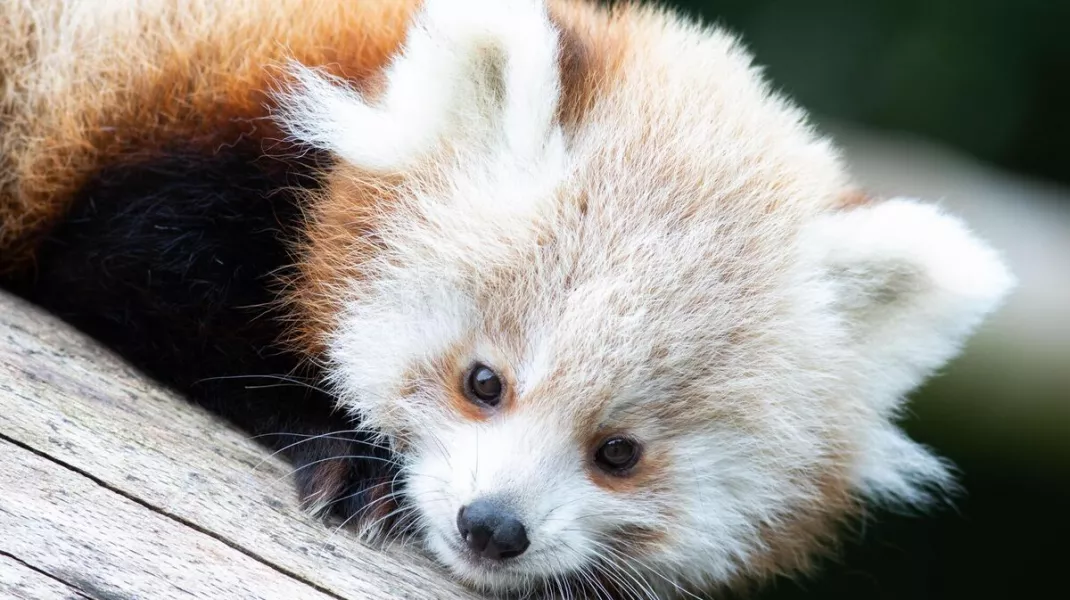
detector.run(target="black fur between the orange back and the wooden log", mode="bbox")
[4,141,393,516]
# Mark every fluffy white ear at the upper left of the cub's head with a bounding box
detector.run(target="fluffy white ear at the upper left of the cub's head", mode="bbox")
[278,0,560,171]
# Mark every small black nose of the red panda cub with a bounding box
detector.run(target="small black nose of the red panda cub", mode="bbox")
[457,501,530,560]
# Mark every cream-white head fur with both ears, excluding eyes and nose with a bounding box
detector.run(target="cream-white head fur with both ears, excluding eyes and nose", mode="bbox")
[273,0,1012,595]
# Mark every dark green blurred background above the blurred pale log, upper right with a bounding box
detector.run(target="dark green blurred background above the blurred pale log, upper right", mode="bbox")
[668,0,1070,182]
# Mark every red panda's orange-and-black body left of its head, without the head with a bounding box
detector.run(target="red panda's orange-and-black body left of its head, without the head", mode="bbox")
[0,0,434,532]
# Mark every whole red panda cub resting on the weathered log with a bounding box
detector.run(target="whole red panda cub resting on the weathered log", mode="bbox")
[0,0,1012,598]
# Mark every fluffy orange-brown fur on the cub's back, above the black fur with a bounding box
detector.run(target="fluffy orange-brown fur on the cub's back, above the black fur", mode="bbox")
[0,1,416,265]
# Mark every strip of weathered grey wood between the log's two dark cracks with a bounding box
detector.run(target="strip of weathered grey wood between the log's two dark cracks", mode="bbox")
[0,442,330,600]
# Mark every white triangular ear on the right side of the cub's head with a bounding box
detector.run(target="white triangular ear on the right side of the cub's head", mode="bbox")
[803,199,1014,409]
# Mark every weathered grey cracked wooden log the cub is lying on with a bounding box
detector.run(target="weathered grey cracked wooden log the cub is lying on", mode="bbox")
[0,288,475,599]
